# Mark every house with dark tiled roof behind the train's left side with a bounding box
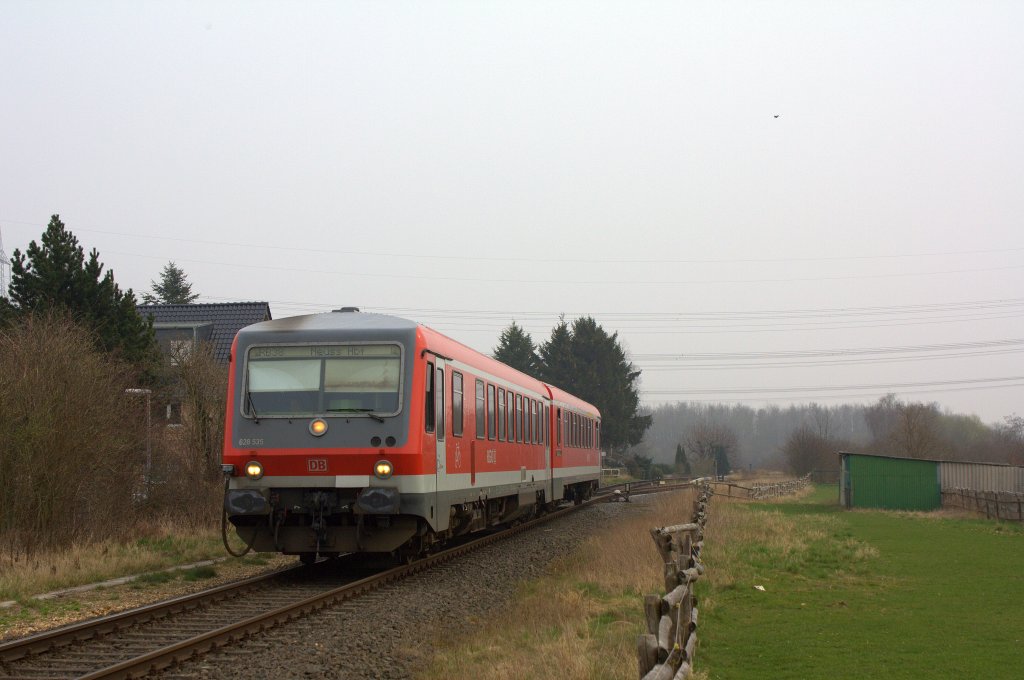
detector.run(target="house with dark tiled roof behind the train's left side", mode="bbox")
[136,302,271,364]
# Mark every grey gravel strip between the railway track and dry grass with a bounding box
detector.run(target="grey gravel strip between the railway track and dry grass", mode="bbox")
[162,503,632,680]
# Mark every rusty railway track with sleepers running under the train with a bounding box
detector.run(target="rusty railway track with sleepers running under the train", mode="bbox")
[0,482,686,680]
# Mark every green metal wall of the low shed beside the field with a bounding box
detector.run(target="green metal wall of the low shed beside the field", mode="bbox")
[840,453,942,510]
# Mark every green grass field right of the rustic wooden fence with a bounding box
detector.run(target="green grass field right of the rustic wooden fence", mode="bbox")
[697,486,1024,679]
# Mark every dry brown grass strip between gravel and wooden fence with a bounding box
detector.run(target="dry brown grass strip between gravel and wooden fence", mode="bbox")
[422,491,693,680]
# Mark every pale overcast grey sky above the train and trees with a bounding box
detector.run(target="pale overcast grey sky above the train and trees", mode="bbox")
[0,0,1024,422]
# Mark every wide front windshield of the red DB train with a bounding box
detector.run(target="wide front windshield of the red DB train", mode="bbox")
[242,343,401,418]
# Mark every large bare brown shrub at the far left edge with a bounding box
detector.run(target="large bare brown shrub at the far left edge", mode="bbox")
[0,312,145,556]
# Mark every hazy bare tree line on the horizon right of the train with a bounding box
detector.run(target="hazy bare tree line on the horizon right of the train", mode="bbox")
[629,394,1024,474]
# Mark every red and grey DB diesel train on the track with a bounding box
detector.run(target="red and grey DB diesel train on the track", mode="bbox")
[223,307,601,560]
